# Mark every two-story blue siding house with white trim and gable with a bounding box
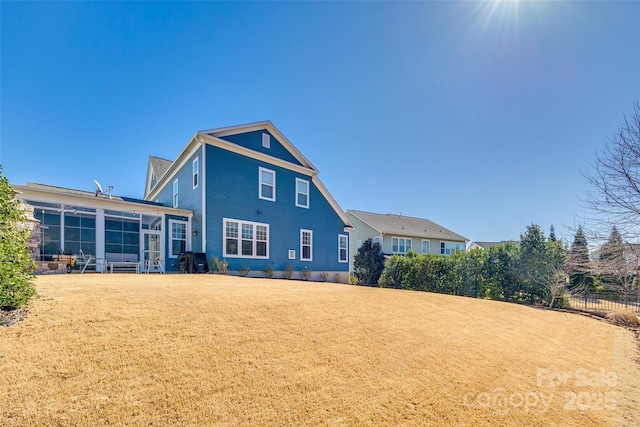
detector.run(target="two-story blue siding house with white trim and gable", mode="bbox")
[144,121,353,281]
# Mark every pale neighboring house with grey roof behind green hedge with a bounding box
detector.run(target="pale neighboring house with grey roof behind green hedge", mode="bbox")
[347,210,468,271]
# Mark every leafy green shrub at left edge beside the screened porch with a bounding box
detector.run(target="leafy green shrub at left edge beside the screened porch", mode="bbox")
[0,166,35,310]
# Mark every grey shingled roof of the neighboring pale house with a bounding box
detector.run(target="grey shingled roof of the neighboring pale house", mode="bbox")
[347,209,469,242]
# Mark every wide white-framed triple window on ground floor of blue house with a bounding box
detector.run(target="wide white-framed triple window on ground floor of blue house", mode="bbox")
[223,218,269,258]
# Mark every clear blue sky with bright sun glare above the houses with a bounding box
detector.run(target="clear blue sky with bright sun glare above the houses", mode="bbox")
[0,1,640,241]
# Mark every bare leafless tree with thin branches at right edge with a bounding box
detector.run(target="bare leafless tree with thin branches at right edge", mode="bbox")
[583,102,640,236]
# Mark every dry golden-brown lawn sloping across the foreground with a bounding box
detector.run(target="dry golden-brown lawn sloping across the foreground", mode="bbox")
[0,274,640,426]
